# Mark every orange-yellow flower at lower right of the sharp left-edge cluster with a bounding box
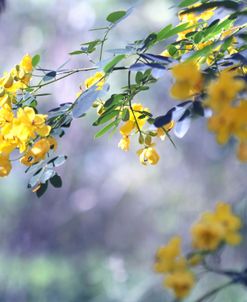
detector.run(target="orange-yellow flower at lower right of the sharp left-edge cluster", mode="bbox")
[20,138,50,166]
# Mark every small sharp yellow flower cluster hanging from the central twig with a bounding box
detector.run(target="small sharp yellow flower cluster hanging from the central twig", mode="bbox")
[118,104,174,166]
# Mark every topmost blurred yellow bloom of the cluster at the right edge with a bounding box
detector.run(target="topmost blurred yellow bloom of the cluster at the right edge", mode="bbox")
[206,69,245,112]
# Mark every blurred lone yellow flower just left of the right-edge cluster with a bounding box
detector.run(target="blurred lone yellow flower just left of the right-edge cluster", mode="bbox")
[171,61,203,100]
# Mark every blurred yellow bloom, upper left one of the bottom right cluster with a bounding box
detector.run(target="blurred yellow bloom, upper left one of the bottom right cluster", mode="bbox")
[154,236,183,273]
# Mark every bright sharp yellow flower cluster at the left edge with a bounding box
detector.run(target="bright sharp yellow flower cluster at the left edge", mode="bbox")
[0,55,54,177]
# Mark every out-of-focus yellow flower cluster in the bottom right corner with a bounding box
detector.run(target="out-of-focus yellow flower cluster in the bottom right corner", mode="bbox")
[154,202,241,299]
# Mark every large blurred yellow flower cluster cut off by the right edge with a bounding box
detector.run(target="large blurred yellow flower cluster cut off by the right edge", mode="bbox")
[206,69,247,162]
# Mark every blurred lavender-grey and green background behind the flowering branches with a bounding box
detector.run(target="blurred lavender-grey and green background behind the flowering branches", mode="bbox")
[0,0,247,302]
